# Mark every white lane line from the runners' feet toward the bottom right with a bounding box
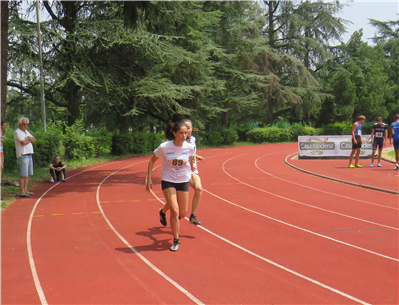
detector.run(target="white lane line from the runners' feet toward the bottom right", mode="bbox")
[152,192,370,305]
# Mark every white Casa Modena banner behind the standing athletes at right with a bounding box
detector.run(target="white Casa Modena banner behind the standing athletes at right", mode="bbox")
[298,135,373,158]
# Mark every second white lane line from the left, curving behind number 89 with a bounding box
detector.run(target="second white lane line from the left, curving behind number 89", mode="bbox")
[96,160,204,305]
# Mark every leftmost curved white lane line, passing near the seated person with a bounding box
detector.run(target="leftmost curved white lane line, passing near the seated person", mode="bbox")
[26,161,148,305]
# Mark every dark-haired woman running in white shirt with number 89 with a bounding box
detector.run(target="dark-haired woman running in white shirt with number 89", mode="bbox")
[146,121,195,251]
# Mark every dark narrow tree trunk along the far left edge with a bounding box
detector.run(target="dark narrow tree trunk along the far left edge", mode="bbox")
[0,0,8,122]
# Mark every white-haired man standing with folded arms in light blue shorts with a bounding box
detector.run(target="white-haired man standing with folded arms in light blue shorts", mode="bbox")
[14,117,36,197]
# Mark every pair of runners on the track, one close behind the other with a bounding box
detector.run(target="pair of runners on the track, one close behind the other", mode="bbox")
[146,119,203,251]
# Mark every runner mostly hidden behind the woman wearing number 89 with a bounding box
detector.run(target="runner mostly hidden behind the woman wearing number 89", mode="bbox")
[183,119,204,225]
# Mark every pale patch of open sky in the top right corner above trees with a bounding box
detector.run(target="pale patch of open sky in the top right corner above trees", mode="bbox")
[338,0,399,44]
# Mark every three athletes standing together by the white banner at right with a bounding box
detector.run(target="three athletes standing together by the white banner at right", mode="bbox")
[349,114,399,170]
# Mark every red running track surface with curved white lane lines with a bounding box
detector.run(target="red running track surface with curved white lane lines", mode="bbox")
[0,144,399,304]
